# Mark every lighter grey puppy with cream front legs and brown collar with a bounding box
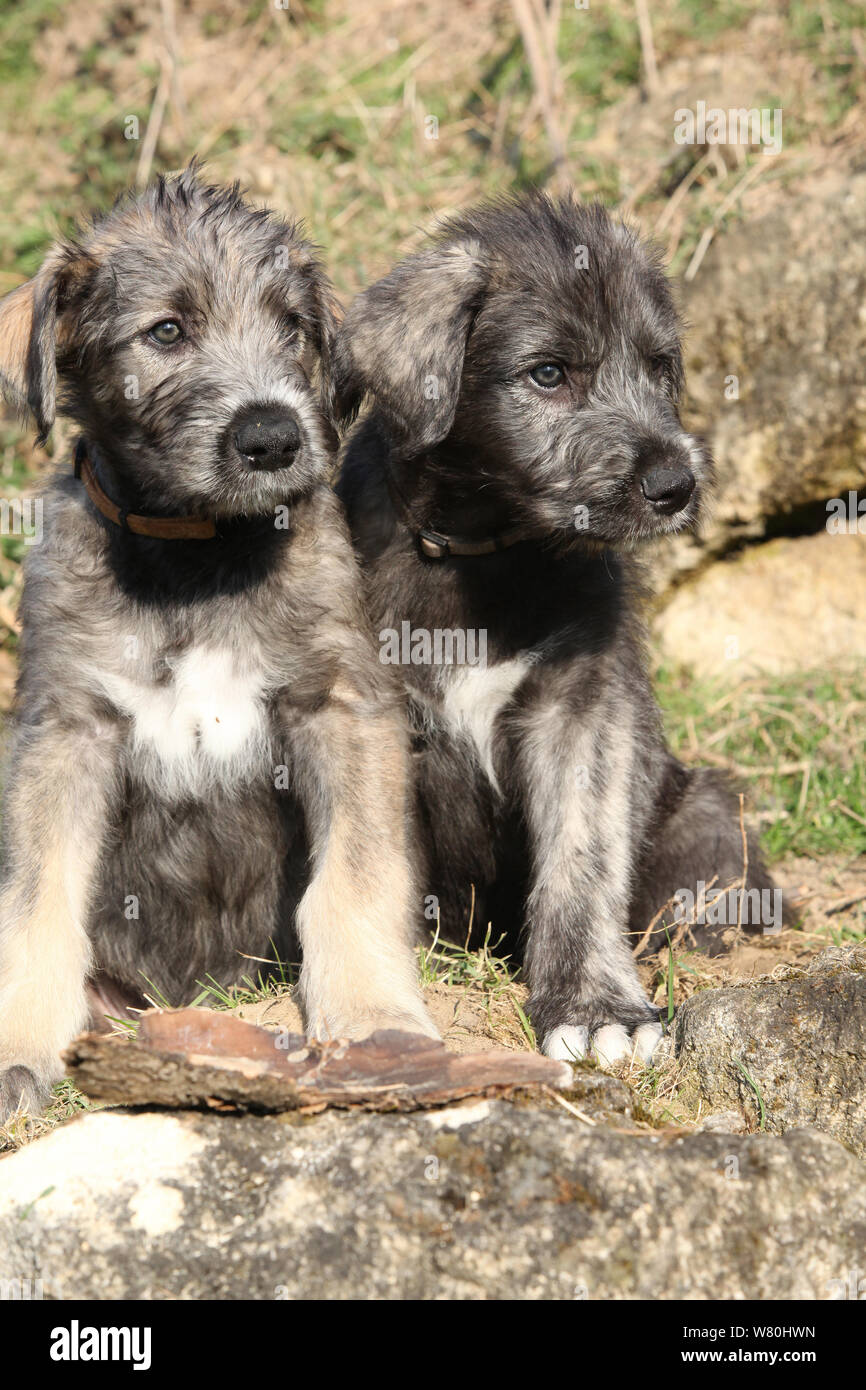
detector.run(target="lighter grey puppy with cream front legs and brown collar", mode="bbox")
[0,171,435,1116]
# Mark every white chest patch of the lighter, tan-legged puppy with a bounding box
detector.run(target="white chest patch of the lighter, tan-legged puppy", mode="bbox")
[101,648,267,791]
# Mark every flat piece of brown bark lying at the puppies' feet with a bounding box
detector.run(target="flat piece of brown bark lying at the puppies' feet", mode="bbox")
[64,1009,573,1111]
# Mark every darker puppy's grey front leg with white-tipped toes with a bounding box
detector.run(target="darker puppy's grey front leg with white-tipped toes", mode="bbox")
[518,705,662,1062]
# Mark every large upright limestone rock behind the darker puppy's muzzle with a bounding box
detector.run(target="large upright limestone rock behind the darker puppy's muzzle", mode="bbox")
[680,174,866,575]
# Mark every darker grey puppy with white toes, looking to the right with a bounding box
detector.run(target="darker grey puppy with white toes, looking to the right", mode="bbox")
[338,195,770,1059]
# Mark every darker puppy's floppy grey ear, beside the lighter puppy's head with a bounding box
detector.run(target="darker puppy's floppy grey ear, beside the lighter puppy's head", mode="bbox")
[336,240,488,449]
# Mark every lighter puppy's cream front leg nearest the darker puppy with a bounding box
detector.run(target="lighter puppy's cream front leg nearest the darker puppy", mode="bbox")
[291,684,438,1037]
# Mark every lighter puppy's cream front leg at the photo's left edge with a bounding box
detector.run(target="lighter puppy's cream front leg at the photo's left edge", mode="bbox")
[0,717,118,1120]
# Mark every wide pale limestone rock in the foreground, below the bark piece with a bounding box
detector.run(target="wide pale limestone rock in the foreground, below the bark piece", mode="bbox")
[0,1099,866,1300]
